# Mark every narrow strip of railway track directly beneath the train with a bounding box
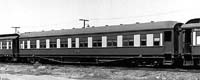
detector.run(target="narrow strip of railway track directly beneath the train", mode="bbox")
[3,63,200,73]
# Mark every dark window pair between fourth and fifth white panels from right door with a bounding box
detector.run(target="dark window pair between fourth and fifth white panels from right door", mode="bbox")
[107,36,117,47]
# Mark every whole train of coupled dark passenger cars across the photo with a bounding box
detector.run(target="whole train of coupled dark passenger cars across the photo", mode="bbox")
[0,18,200,66]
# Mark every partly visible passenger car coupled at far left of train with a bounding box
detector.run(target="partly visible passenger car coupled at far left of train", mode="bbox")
[0,34,19,61]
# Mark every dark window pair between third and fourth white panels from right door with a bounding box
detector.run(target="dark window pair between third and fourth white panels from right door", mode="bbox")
[123,35,134,47]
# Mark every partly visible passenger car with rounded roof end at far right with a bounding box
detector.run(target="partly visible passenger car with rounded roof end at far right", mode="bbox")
[182,18,200,66]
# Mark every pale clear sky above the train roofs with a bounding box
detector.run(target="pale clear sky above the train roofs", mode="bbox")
[0,0,200,34]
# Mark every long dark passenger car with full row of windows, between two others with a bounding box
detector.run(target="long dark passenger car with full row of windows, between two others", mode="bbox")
[19,21,182,65]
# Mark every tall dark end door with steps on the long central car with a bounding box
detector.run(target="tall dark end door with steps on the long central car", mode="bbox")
[164,31,173,65]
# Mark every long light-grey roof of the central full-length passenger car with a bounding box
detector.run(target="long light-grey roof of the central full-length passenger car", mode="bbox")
[20,21,178,38]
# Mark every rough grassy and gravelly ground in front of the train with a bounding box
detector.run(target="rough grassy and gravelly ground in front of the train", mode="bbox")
[0,63,200,80]
